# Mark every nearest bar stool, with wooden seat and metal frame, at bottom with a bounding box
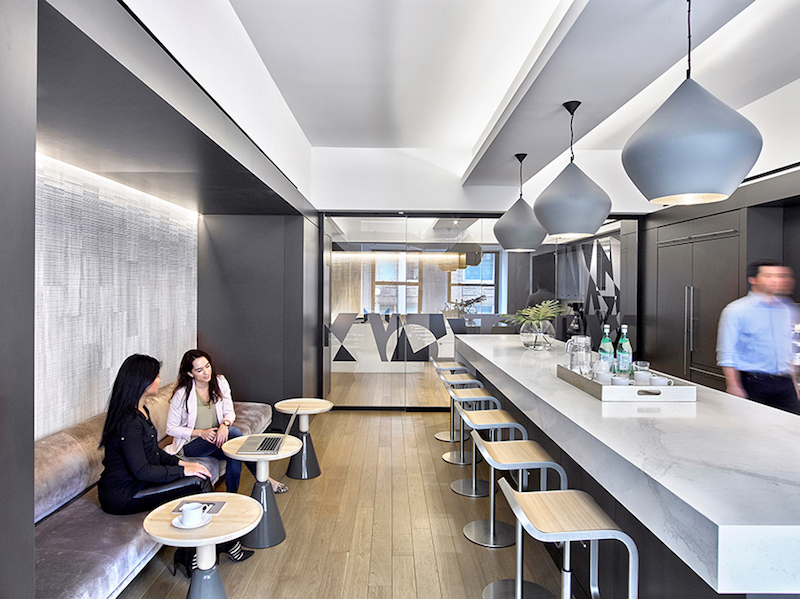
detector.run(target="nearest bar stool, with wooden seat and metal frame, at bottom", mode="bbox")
[490,480,639,599]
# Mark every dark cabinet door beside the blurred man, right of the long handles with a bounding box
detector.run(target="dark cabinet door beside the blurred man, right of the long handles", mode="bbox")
[691,236,739,372]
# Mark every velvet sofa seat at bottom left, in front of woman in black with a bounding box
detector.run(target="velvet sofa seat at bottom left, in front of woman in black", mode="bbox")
[35,488,161,599]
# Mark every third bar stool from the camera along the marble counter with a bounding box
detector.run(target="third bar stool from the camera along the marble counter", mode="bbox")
[450,400,528,497]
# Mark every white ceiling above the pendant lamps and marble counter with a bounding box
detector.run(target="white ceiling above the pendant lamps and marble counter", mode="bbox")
[123,0,800,211]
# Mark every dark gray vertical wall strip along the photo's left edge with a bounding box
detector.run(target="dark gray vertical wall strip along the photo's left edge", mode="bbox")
[0,0,36,597]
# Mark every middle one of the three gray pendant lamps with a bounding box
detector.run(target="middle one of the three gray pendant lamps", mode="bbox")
[533,100,611,237]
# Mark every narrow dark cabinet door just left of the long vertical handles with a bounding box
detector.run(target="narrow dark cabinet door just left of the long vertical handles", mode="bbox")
[650,243,692,377]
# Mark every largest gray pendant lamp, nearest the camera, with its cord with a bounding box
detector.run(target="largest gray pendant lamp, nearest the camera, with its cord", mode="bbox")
[622,0,763,206]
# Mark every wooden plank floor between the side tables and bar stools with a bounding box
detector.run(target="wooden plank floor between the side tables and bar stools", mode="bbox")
[120,411,558,599]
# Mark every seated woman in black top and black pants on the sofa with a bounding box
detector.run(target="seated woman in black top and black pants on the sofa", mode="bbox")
[97,354,253,573]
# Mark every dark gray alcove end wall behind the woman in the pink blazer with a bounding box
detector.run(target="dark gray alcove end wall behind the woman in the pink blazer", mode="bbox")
[197,215,319,424]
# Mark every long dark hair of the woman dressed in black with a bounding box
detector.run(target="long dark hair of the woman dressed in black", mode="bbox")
[99,354,161,447]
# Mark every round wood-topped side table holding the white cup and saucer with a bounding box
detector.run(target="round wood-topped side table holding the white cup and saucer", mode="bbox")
[143,493,262,599]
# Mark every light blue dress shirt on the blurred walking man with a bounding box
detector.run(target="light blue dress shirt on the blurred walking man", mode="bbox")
[717,291,797,374]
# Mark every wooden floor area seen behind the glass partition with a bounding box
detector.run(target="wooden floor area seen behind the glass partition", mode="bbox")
[327,363,450,409]
